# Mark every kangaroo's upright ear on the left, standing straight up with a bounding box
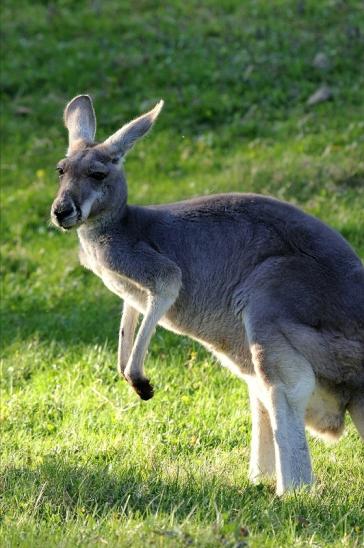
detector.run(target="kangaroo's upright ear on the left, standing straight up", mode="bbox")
[63,95,96,154]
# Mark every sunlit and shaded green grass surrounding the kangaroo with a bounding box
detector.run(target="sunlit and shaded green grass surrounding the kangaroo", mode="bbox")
[0,0,364,548]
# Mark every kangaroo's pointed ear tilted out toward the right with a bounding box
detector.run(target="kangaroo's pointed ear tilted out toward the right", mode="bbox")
[103,101,164,160]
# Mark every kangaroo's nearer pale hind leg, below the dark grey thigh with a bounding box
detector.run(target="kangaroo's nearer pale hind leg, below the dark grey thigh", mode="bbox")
[247,323,315,494]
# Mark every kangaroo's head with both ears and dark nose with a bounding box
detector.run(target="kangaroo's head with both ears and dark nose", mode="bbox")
[51,95,163,229]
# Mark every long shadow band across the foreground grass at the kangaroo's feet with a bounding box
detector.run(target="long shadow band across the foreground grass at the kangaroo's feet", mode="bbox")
[3,455,359,546]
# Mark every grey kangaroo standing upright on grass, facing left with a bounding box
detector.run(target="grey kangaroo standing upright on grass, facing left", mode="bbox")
[51,95,364,494]
